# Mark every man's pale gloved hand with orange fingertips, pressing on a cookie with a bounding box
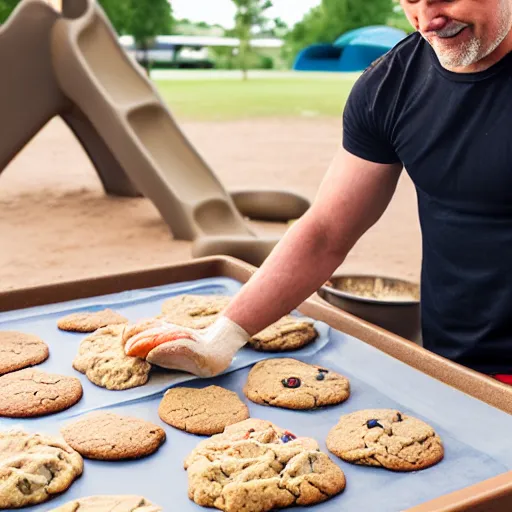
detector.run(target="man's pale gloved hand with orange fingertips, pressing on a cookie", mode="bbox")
[123,316,249,377]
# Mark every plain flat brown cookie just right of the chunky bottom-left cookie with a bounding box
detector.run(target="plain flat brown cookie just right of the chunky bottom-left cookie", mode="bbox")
[61,412,165,460]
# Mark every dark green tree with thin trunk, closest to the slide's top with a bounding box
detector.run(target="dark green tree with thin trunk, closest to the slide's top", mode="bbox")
[124,0,173,74]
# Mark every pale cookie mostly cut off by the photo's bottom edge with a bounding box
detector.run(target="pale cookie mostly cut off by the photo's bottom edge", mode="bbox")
[49,495,163,512]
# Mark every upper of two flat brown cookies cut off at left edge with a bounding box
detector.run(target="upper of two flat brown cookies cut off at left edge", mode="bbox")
[0,331,50,375]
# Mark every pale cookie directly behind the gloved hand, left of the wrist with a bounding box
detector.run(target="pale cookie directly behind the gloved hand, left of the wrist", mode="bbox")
[159,295,231,329]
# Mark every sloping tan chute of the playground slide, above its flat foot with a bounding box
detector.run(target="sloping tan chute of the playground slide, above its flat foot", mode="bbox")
[51,0,252,240]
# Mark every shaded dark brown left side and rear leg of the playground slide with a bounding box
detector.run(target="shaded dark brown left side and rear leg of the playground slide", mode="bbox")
[0,0,138,196]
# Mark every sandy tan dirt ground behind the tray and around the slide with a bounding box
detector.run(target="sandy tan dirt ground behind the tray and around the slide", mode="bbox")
[0,118,421,290]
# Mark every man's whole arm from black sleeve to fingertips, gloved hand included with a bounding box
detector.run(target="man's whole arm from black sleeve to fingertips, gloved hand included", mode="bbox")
[123,148,401,377]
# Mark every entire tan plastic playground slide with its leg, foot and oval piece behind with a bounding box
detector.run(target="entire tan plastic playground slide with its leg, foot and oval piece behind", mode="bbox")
[0,0,309,265]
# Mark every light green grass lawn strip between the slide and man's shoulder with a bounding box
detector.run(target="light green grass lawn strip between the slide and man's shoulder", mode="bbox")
[155,75,355,121]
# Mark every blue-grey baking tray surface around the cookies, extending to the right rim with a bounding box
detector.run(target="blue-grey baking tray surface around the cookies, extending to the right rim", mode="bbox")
[0,279,512,512]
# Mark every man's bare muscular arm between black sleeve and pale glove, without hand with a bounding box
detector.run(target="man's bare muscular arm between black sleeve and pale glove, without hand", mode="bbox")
[225,148,402,335]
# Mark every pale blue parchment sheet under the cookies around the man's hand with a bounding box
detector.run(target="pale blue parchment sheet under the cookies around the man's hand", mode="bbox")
[0,278,330,418]
